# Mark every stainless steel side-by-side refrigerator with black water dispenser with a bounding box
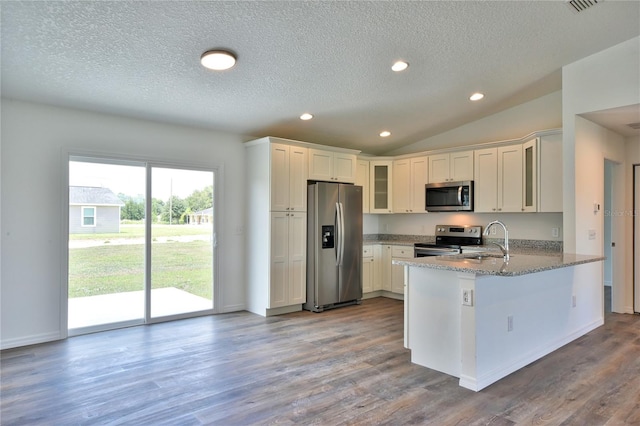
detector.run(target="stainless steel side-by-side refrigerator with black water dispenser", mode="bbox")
[303,182,362,312]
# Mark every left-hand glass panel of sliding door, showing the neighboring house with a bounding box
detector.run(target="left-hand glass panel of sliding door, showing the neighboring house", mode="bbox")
[68,158,146,335]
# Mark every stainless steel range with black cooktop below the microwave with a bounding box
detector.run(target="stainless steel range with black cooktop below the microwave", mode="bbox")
[413,225,482,257]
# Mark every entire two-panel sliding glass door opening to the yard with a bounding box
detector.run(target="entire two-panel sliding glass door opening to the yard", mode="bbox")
[67,156,215,335]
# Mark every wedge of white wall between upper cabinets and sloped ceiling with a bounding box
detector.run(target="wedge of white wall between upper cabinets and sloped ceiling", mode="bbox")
[385,91,562,155]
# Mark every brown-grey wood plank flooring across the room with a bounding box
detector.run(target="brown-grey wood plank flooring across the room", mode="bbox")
[0,298,640,425]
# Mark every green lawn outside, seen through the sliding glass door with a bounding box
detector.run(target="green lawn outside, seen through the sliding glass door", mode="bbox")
[69,240,213,299]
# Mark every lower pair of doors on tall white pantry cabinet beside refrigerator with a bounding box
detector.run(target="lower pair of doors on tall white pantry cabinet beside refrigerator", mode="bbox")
[268,212,307,309]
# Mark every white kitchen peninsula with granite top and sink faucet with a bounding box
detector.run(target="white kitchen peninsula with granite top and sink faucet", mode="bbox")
[394,253,604,391]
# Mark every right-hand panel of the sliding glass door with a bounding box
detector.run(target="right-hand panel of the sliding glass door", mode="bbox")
[150,167,214,318]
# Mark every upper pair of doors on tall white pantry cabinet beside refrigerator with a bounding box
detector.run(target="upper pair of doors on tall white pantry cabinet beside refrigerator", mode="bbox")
[270,143,308,211]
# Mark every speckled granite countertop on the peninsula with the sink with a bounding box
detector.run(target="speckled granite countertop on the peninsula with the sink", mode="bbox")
[393,253,605,277]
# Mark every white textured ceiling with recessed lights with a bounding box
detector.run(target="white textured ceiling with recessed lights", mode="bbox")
[0,0,640,154]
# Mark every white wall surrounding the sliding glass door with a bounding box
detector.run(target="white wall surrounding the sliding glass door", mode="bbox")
[0,99,245,348]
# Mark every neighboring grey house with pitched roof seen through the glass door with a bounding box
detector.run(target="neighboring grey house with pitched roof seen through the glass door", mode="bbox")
[69,186,124,234]
